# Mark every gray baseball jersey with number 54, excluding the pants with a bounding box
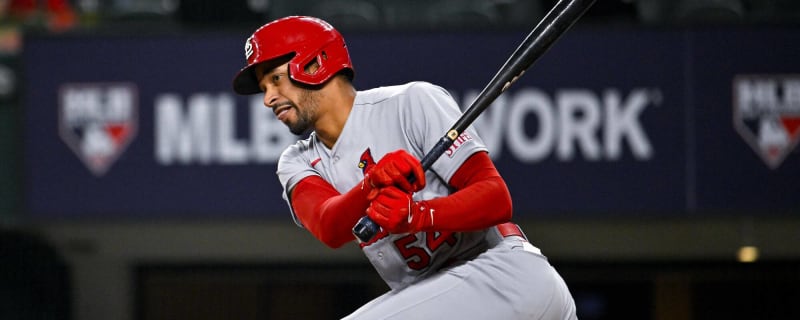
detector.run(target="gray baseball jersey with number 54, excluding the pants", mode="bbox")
[278,82,486,289]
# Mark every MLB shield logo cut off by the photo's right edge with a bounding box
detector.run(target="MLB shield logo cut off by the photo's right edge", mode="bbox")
[733,75,800,169]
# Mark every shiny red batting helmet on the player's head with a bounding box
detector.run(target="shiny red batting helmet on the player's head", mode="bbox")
[233,16,353,94]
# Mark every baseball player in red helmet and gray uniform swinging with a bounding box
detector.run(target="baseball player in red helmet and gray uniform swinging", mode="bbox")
[233,16,576,319]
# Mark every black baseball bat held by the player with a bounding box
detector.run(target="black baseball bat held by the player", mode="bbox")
[353,0,596,242]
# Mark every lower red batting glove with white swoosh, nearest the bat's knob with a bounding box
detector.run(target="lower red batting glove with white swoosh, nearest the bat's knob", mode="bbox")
[367,186,434,233]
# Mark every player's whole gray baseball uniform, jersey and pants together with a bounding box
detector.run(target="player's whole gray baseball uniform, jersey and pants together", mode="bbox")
[277,82,575,319]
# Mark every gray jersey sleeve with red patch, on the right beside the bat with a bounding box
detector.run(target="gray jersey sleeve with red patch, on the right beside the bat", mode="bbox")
[400,82,488,181]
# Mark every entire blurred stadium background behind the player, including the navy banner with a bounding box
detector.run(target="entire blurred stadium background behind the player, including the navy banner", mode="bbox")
[0,0,800,320]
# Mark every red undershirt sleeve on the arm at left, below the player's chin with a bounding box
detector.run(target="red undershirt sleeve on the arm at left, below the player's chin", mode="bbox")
[290,176,370,248]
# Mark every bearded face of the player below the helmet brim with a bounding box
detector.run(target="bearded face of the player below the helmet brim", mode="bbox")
[256,63,319,135]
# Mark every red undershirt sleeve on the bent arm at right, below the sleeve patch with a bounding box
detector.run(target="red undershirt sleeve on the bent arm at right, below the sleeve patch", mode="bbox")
[423,152,512,231]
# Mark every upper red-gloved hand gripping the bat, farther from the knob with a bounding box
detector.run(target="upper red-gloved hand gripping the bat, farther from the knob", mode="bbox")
[364,149,425,192]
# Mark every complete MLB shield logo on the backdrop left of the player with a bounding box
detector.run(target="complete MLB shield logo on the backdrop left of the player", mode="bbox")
[58,83,138,176]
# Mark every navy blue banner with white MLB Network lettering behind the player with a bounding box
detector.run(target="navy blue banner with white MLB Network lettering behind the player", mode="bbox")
[24,28,800,218]
